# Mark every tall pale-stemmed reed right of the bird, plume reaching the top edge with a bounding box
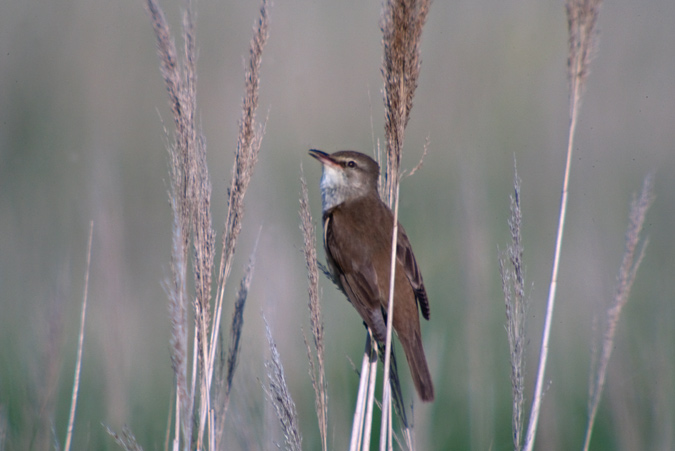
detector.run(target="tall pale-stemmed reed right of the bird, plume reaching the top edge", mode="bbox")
[524,0,601,451]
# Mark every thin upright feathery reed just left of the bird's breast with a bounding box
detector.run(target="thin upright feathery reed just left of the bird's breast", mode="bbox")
[300,170,328,451]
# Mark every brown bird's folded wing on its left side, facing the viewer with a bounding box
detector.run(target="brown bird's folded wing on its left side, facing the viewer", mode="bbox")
[323,209,387,340]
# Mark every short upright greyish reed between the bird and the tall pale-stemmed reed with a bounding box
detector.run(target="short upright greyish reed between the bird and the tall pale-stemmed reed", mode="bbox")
[499,167,528,450]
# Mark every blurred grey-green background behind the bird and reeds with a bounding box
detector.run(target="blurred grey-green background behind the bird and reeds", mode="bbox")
[0,0,675,450]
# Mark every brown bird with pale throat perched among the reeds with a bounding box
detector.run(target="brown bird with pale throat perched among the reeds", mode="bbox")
[309,149,434,401]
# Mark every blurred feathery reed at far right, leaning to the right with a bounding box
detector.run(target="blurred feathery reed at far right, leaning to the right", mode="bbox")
[584,174,654,450]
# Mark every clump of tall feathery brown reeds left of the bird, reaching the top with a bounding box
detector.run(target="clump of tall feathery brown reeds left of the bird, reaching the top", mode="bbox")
[146,0,269,450]
